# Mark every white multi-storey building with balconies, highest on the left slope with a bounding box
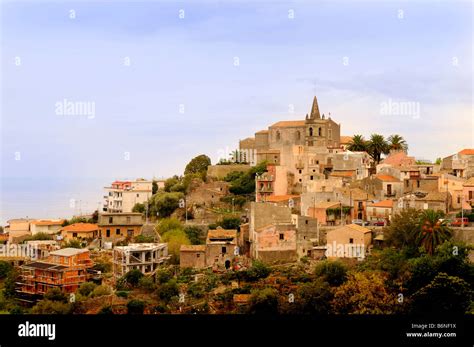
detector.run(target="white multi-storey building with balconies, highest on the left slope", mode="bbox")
[103,179,153,213]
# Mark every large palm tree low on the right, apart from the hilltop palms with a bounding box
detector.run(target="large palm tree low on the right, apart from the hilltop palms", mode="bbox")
[417,210,452,255]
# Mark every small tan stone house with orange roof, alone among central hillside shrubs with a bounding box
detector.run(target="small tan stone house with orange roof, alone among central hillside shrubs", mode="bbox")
[206,228,238,269]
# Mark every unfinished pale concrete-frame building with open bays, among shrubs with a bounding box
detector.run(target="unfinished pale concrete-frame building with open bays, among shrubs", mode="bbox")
[112,243,169,279]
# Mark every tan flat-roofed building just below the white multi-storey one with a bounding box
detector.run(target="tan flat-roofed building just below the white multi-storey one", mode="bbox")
[98,212,143,242]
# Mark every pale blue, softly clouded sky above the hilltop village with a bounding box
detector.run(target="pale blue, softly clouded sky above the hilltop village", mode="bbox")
[0,0,474,223]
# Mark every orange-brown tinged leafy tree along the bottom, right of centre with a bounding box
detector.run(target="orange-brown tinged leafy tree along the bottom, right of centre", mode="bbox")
[332,272,398,314]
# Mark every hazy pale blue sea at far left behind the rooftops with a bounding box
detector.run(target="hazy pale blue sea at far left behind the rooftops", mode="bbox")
[0,177,110,226]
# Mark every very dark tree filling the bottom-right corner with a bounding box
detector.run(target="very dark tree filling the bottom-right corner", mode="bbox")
[411,272,474,315]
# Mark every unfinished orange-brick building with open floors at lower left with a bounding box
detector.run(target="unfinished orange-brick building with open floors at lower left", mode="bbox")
[17,248,93,295]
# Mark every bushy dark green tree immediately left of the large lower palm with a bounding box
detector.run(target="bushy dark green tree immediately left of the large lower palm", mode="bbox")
[384,208,421,256]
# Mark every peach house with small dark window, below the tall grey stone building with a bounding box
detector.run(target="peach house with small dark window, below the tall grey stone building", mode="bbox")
[252,223,298,263]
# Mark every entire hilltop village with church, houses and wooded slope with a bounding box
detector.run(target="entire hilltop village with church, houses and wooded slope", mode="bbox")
[0,97,474,314]
